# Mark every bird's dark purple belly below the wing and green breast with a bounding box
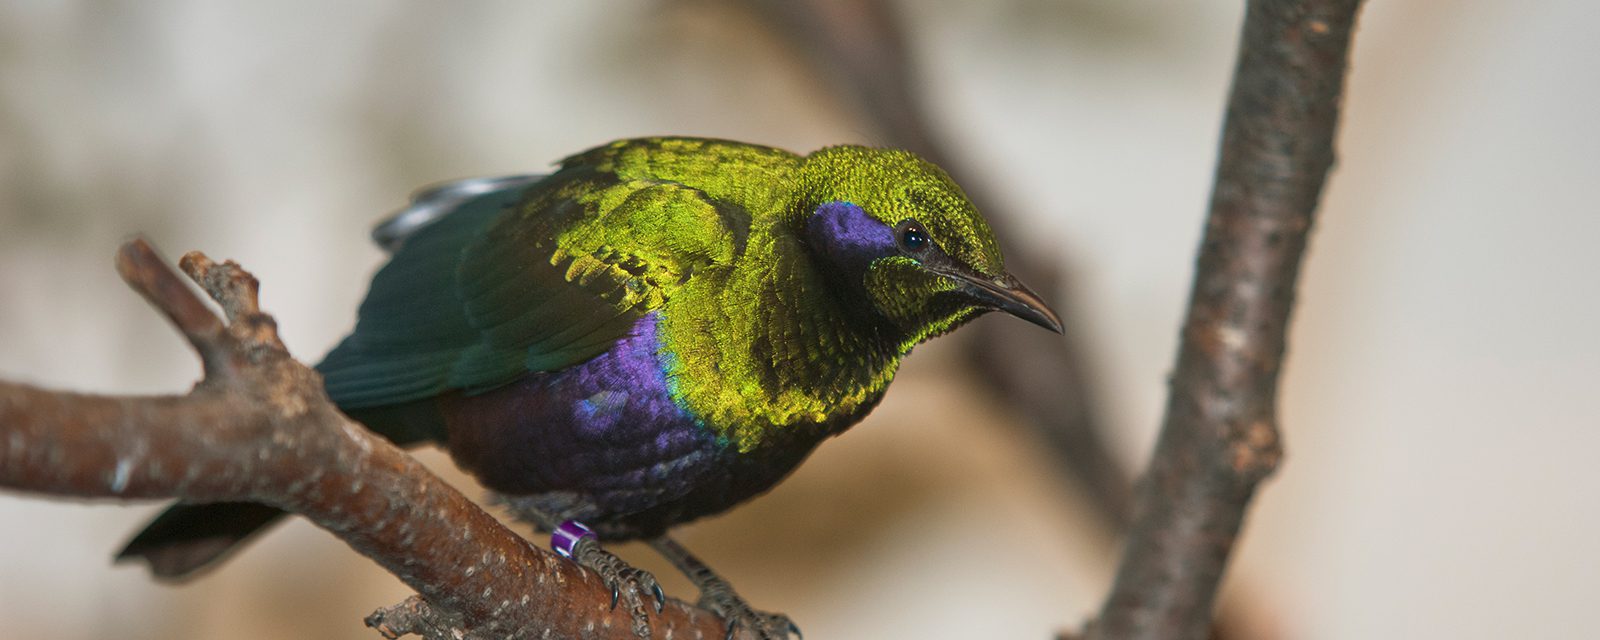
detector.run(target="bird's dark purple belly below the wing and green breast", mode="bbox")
[440,317,819,539]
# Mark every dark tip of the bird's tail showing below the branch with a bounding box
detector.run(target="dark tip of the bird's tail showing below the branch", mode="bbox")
[117,502,288,579]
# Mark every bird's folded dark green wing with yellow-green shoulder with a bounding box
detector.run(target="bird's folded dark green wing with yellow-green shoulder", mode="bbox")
[317,166,749,410]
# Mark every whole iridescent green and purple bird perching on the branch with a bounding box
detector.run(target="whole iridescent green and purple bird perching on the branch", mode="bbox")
[118,138,1061,637]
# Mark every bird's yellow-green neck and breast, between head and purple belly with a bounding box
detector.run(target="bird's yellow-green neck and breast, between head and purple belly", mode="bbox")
[661,222,909,451]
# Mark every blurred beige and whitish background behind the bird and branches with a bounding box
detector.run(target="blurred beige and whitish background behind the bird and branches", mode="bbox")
[0,0,1600,640]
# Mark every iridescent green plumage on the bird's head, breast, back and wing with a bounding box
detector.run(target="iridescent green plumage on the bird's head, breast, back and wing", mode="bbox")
[322,138,1030,451]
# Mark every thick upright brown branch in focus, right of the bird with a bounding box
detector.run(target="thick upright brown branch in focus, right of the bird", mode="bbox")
[1090,0,1360,638]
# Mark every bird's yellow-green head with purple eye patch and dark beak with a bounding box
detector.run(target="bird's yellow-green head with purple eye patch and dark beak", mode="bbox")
[800,146,1061,347]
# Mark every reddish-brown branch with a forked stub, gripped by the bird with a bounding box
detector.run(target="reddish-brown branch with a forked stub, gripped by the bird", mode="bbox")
[0,240,723,638]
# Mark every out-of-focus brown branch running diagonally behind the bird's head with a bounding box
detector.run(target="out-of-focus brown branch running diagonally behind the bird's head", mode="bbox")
[750,0,1130,544]
